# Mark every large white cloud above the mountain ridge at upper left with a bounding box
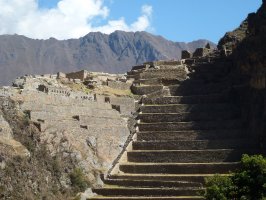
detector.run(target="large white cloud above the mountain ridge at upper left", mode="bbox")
[0,0,152,39]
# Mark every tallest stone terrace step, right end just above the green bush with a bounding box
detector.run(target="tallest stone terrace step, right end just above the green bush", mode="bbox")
[127,149,257,163]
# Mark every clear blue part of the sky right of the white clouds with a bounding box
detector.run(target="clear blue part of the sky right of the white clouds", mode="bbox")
[105,0,261,42]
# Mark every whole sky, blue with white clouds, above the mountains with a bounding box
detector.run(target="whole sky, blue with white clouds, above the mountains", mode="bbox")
[0,0,262,42]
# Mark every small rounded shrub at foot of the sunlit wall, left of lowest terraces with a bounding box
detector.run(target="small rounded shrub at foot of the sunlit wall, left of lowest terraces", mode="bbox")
[69,168,89,192]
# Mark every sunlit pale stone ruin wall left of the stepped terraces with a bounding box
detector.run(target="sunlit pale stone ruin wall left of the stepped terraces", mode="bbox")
[0,71,135,188]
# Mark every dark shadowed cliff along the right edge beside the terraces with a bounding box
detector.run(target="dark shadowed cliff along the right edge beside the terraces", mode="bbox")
[218,1,266,152]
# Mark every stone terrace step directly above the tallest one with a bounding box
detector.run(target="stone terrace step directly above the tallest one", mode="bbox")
[132,139,255,150]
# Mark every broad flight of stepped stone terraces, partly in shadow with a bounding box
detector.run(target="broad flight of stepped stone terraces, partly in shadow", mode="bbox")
[90,55,258,200]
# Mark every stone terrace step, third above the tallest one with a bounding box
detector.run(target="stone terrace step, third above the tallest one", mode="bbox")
[137,120,242,131]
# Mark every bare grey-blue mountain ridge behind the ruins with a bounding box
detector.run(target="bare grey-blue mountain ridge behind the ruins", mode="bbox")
[0,31,215,85]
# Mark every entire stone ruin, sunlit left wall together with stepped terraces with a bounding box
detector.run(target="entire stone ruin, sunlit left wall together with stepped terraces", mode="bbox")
[0,13,266,197]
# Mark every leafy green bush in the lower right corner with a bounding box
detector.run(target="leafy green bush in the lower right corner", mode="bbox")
[204,155,266,200]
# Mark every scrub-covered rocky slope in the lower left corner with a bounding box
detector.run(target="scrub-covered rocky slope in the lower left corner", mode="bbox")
[0,98,75,200]
